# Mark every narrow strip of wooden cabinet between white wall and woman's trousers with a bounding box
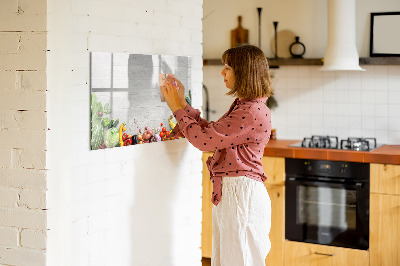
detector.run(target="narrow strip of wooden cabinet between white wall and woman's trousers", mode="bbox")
[201,152,213,258]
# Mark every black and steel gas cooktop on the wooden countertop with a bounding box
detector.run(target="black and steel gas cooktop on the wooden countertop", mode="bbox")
[289,135,382,151]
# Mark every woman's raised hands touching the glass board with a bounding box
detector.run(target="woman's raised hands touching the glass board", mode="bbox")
[160,77,186,113]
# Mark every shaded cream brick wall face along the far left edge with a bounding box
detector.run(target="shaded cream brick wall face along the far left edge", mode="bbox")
[0,1,47,265]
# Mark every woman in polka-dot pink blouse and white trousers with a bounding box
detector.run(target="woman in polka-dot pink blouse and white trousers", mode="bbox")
[161,45,272,266]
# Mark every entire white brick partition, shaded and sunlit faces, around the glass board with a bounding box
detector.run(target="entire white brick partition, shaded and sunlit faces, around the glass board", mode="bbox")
[0,0,202,266]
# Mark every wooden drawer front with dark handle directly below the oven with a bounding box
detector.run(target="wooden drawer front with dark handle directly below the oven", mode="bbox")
[284,240,369,266]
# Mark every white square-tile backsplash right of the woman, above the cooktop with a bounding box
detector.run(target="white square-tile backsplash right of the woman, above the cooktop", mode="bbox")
[272,65,400,144]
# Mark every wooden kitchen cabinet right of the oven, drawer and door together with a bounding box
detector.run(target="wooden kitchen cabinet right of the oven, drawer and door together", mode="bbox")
[369,164,400,266]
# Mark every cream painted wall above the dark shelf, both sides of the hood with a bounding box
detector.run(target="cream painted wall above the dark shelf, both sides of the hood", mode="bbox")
[203,0,400,59]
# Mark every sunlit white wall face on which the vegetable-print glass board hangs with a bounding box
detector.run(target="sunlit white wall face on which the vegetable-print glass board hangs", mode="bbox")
[47,0,202,266]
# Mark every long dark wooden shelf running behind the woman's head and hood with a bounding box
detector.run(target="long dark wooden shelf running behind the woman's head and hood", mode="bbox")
[203,57,400,68]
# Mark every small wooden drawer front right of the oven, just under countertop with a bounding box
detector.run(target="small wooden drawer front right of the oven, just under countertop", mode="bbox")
[370,163,400,195]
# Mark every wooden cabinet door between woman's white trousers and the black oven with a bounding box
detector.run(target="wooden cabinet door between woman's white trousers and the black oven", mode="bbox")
[265,184,285,266]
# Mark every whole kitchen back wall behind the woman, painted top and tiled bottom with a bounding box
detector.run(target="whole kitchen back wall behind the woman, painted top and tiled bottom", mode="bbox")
[203,0,400,144]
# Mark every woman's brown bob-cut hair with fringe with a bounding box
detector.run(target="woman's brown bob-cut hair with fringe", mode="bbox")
[221,44,274,99]
